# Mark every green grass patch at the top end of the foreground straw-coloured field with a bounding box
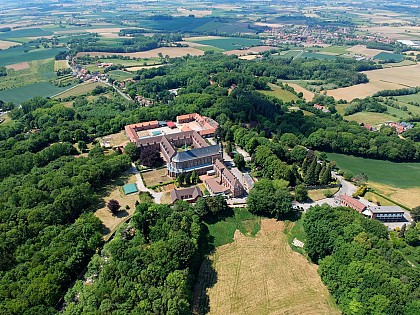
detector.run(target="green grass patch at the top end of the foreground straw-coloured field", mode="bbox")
[207,208,261,247]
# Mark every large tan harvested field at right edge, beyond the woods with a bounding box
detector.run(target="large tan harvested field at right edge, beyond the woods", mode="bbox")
[327,64,420,101]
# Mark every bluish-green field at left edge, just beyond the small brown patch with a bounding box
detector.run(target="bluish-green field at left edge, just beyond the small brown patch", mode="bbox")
[0,46,67,66]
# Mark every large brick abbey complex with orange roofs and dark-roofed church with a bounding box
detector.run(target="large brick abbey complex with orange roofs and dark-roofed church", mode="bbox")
[125,113,245,202]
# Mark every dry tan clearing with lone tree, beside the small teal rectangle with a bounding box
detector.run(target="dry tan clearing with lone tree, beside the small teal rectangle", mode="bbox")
[95,174,139,238]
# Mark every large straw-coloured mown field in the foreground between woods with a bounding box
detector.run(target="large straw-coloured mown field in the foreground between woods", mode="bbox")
[198,219,340,315]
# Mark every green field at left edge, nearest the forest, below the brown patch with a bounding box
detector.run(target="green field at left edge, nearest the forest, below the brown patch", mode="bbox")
[0,82,68,104]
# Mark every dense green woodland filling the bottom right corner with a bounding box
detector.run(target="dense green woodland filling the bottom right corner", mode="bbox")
[304,205,420,315]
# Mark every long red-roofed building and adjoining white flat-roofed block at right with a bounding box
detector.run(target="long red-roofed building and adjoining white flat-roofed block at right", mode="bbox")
[335,195,405,222]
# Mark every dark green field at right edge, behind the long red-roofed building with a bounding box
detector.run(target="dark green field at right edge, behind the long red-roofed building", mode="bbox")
[327,153,420,188]
